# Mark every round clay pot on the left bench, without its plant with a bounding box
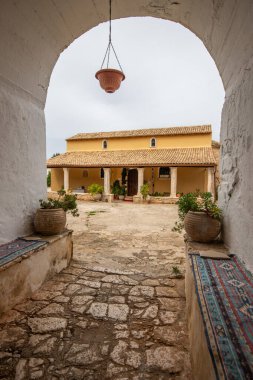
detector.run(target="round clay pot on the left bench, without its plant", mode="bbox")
[34,208,66,235]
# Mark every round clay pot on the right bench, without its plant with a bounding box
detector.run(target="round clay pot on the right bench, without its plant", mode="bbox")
[184,211,221,243]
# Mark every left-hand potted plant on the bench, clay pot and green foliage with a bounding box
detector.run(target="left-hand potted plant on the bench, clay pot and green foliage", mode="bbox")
[34,190,79,235]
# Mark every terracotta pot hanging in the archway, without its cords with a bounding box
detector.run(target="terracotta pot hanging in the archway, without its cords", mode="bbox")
[95,69,125,93]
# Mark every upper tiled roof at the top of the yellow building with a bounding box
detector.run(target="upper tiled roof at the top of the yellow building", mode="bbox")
[66,125,212,141]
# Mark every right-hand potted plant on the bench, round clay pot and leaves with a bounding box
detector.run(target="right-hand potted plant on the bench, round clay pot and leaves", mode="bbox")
[172,192,222,243]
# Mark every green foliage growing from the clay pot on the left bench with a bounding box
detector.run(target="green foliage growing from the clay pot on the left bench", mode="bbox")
[39,190,79,216]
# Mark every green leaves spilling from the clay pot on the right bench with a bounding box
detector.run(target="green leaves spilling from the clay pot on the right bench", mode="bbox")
[172,190,222,232]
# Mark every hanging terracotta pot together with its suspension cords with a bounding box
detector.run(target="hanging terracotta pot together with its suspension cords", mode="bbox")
[95,0,125,94]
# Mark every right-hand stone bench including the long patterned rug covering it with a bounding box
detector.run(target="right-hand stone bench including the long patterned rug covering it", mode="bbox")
[185,241,253,380]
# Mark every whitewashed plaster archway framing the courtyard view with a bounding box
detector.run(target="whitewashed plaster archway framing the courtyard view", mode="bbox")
[0,0,253,267]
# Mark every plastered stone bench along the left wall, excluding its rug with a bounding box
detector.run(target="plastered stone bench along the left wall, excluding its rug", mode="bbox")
[0,230,73,315]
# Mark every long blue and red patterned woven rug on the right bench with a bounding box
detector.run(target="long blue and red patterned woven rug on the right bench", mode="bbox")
[190,254,253,380]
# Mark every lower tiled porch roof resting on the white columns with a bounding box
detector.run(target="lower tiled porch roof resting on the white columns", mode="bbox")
[47,147,217,168]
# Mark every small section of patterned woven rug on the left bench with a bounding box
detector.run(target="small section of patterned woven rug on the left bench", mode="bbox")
[0,238,48,267]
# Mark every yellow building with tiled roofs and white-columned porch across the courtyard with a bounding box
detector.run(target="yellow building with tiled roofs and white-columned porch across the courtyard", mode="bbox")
[47,125,219,202]
